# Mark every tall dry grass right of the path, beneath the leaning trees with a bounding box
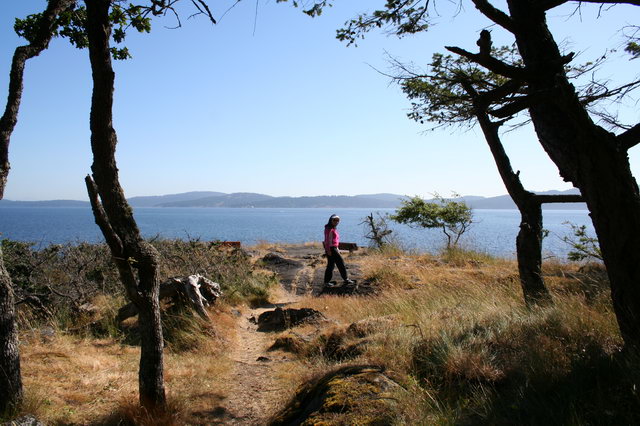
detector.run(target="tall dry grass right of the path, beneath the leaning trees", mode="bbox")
[298,248,640,424]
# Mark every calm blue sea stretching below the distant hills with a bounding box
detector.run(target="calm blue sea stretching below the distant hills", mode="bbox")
[0,207,593,258]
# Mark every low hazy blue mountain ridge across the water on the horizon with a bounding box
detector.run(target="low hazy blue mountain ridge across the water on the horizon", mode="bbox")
[0,189,586,210]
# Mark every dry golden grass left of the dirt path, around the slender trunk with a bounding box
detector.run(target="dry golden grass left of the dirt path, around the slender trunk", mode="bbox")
[21,311,234,424]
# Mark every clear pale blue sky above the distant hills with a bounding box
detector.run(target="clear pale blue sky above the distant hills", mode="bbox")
[0,0,640,200]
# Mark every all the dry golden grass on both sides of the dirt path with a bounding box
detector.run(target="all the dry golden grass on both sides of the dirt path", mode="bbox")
[11,246,640,424]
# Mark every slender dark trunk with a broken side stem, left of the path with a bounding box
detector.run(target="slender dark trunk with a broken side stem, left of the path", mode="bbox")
[86,0,166,409]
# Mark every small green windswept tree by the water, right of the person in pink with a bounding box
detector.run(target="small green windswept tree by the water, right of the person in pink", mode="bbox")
[390,194,473,249]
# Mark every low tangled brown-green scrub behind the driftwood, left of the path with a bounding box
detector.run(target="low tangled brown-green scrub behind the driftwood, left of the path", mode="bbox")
[2,239,276,337]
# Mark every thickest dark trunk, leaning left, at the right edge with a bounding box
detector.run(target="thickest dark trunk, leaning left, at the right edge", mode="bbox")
[508,0,640,348]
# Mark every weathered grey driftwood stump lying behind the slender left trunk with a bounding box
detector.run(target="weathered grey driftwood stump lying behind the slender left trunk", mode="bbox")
[117,274,222,322]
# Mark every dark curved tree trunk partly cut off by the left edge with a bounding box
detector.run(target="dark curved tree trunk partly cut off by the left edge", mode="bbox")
[0,0,75,413]
